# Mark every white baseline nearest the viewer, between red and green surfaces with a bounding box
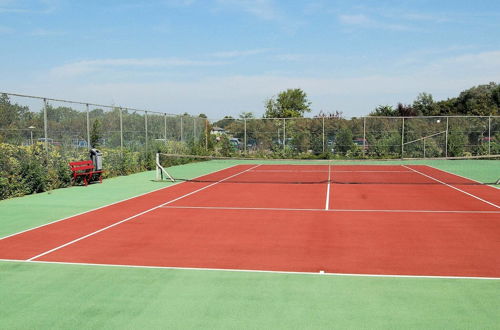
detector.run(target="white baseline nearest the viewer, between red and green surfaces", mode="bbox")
[0,259,500,280]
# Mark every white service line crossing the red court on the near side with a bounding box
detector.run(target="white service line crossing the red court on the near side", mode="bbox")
[161,205,500,214]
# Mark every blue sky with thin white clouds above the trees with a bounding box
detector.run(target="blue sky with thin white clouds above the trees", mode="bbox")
[0,0,500,118]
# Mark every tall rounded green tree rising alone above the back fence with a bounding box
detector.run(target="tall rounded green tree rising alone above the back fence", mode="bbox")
[264,88,311,118]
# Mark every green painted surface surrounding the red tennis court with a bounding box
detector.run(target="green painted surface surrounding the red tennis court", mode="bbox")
[0,160,500,329]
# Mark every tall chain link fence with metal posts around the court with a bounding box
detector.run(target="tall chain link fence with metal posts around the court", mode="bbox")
[0,93,500,158]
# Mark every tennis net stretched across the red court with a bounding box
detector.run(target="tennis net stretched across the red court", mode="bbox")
[156,153,500,187]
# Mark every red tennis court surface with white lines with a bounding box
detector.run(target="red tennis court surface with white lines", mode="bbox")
[0,165,500,278]
